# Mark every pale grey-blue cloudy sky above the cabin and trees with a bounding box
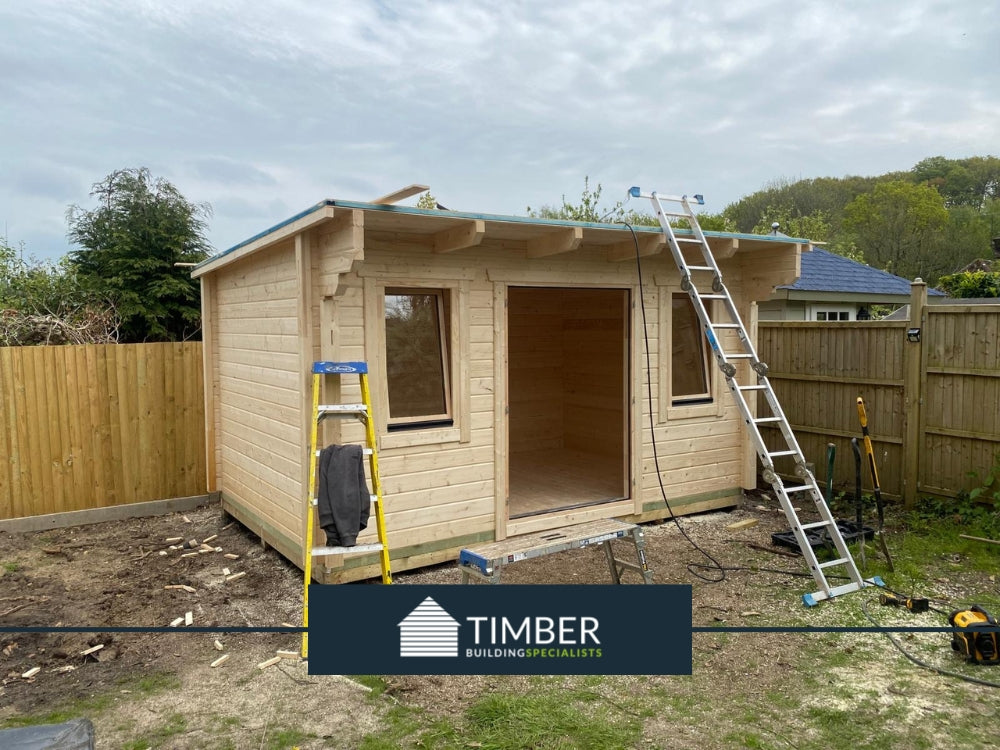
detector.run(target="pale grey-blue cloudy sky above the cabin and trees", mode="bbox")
[0,0,1000,258]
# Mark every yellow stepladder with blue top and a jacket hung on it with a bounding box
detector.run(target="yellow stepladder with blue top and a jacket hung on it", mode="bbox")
[302,362,392,659]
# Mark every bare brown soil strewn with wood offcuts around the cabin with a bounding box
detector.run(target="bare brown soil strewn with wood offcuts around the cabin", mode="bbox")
[0,494,992,748]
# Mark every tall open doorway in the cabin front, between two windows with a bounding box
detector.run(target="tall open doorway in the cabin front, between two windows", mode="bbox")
[507,287,630,518]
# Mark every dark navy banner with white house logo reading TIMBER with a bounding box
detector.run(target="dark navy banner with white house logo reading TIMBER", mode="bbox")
[309,585,692,675]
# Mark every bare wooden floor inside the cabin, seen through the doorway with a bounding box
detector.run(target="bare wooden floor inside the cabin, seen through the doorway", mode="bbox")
[508,449,625,518]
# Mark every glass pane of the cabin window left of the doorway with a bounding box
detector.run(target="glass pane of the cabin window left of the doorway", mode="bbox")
[385,289,447,419]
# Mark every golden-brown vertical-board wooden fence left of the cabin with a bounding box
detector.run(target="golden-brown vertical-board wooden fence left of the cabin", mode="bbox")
[0,342,205,519]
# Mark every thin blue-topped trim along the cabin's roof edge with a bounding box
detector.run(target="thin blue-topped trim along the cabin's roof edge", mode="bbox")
[195,197,809,270]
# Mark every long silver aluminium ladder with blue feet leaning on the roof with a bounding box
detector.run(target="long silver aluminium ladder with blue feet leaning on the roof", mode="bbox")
[629,187,880,606]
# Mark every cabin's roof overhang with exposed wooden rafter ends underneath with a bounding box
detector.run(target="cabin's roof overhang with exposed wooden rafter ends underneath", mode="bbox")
[192,200,809,278]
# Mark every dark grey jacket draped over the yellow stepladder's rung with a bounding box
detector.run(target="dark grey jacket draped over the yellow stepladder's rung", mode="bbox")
[318,445,371,547]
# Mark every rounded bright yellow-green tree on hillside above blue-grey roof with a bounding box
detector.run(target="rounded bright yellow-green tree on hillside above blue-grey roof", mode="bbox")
[844,181,950,284]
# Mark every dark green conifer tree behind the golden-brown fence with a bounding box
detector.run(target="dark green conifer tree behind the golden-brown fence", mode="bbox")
[67,167,211,342]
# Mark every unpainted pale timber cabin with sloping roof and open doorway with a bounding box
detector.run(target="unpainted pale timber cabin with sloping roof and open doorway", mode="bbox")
[193,200,803,582]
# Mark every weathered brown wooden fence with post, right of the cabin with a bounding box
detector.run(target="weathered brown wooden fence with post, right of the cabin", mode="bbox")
[758,284,1000,503]
